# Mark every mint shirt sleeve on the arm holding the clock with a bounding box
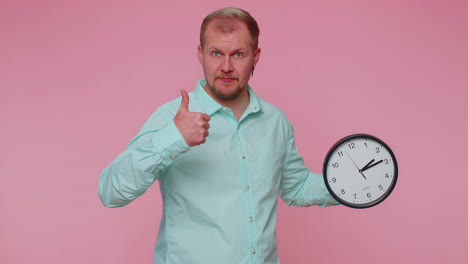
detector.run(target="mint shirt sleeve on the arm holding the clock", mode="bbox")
[280,122,339,207]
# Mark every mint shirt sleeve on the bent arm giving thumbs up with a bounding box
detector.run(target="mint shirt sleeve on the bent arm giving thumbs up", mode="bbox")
[99,106,189,207]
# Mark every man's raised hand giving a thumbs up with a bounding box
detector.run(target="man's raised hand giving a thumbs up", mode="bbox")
[174,90,210,147]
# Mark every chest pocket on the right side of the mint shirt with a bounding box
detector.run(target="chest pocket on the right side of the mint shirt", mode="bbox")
[249,144,284,183]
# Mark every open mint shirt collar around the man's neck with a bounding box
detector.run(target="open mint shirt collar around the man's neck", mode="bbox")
[195,79,261,116]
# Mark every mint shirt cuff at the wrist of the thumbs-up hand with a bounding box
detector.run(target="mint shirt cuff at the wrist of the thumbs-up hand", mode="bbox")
[153,121,190,164]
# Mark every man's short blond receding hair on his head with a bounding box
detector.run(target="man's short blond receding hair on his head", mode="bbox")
[200,7,260,50]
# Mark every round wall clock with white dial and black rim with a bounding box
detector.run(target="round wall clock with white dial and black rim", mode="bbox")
[323,134,398,208]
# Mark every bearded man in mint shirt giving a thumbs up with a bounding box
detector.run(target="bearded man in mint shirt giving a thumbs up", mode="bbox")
[99,8,337,264]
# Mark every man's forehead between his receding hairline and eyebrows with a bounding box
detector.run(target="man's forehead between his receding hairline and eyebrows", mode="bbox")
[205,18,252,46]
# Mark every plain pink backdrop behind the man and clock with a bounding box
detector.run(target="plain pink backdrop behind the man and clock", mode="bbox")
[0,0,468,264]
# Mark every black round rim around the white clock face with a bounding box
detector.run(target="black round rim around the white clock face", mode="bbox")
[323,133,398,209]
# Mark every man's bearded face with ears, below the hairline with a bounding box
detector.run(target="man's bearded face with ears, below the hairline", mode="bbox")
[198,19,260,101]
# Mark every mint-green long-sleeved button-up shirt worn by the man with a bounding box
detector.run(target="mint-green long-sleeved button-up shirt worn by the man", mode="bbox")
[99,80,338,264]
